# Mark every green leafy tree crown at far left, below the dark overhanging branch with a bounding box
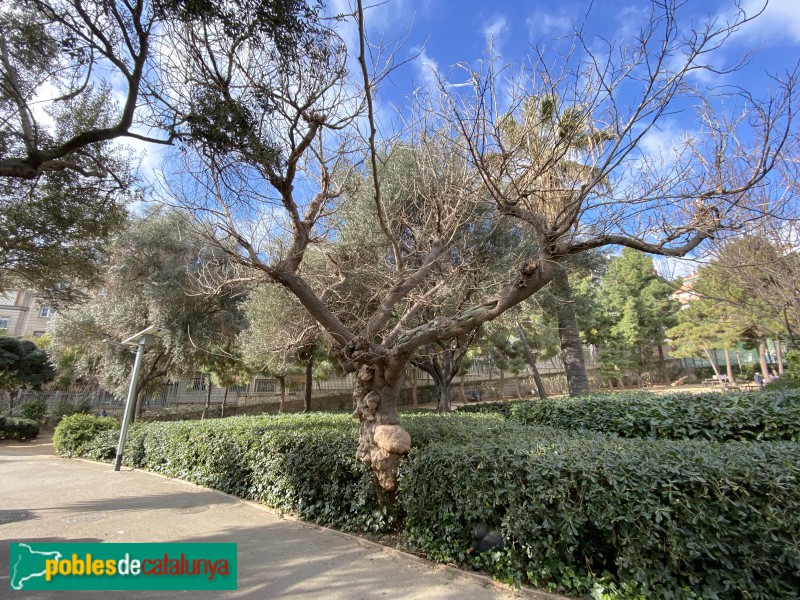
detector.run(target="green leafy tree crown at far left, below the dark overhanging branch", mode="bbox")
[0,81,138,298]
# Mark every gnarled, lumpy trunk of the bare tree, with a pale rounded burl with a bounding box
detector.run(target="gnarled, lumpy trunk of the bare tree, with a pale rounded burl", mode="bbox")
[352,362,411,491]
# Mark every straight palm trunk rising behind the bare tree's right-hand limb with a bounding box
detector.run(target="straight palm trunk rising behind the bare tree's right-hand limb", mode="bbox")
[552,266,589,397]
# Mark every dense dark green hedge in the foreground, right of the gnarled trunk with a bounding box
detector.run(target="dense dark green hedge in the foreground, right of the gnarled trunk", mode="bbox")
[399,428,800,598]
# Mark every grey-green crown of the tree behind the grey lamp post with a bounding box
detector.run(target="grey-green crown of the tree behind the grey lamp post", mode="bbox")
[50,209,243,397]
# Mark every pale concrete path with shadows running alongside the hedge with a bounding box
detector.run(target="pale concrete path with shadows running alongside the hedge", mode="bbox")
[0,442,555,600]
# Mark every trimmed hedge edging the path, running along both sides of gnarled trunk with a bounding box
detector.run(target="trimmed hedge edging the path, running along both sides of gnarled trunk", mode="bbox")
[57,414,800,598]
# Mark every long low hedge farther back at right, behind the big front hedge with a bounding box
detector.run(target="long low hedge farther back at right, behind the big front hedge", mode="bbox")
[458,391,800,442]
